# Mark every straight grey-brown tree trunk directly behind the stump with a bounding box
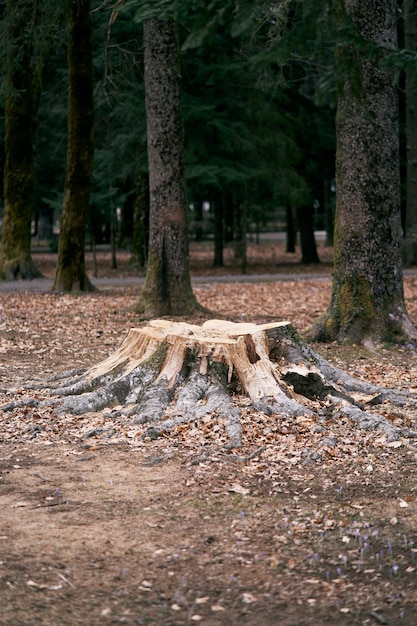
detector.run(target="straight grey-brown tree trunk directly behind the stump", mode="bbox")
[136,19,197,317]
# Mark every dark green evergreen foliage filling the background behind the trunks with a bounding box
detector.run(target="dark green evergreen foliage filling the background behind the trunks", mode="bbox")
[4,0,416,260]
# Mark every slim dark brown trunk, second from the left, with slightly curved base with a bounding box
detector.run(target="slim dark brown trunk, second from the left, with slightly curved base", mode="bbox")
[53,0,95,292]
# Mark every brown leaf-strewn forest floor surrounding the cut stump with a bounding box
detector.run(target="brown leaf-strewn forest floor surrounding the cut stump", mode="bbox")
[0,244,417,626]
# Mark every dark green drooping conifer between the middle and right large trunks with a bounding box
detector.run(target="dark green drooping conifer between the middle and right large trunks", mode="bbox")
[181,3,312,267]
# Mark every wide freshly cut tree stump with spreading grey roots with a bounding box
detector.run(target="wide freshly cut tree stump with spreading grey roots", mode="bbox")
[18,319,417,448]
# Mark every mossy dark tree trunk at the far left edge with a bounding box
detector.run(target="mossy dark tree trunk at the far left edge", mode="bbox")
[0,0,41,280]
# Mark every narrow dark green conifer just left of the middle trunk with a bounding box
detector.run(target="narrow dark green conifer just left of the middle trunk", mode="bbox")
[91,3,148,260]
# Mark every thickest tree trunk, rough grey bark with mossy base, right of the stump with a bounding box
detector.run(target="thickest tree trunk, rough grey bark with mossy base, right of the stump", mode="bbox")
[313,0,417,342]
